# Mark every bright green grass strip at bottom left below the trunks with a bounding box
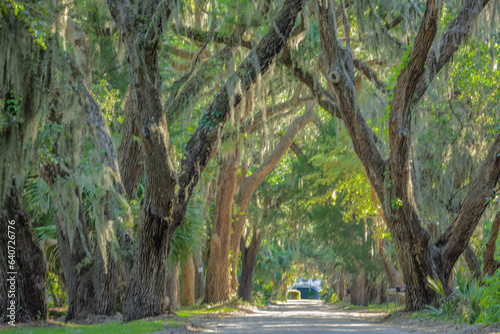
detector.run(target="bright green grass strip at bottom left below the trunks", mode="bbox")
[5,319,184,334]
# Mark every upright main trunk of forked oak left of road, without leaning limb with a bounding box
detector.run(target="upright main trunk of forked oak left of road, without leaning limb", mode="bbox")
[109,1,176,321]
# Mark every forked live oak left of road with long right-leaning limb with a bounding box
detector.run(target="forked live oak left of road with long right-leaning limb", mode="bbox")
[109,0,303,320]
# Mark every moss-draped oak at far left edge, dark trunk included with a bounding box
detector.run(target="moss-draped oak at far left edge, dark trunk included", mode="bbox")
[0,10,53,323]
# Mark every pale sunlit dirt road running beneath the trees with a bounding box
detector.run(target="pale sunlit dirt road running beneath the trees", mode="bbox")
[196,300,417,334]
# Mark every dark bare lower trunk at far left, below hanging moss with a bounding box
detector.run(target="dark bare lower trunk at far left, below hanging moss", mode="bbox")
[0,182,47,324]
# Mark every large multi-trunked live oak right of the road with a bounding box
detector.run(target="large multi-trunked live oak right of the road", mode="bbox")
[314,0,500,310]
